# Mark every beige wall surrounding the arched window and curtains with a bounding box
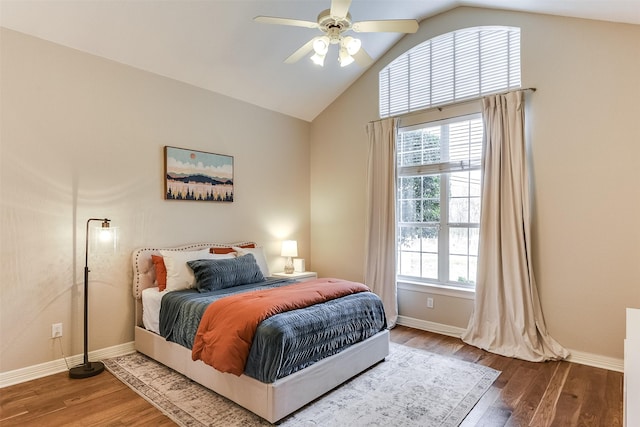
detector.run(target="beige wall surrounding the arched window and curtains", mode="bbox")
[311,8,640,359]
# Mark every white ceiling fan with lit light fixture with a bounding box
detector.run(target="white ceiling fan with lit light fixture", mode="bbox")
[254,0,418,67]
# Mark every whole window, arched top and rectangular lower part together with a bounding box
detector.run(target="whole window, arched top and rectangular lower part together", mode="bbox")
[379,26,521,289]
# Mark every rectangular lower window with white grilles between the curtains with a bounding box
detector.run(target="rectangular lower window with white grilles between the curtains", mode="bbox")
[397,114,483,287]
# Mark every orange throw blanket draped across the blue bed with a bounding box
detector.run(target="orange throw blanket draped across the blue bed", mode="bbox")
[191,279,369,376]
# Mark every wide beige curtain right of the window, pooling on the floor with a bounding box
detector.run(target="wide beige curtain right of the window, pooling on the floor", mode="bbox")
[462,91,569,362]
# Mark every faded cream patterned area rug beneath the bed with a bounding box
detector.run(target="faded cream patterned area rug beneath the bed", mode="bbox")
[103,343,500,427]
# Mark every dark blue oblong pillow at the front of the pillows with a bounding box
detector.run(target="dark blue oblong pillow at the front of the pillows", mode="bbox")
[187,254,264,292]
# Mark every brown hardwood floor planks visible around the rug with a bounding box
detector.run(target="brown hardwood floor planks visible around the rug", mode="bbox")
[0,326,623,427]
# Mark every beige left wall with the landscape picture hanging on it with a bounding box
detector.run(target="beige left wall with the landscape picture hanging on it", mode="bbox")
[0,29,310,372]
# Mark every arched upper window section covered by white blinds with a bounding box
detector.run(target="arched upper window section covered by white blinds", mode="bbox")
[379,26,521,117]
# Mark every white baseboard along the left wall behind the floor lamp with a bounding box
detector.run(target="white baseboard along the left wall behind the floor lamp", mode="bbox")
[0,341,136,388]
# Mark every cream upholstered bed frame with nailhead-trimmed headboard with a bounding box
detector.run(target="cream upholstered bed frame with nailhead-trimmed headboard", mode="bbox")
[132,242,389,423]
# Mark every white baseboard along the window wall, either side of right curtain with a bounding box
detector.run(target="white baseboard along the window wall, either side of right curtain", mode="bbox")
[397,316,624,372]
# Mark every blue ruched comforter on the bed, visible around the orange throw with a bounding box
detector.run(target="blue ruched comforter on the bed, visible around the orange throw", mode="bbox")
[160,278,386,383]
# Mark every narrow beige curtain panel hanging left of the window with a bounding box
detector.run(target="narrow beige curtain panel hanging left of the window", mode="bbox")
[364,119,398,328]
